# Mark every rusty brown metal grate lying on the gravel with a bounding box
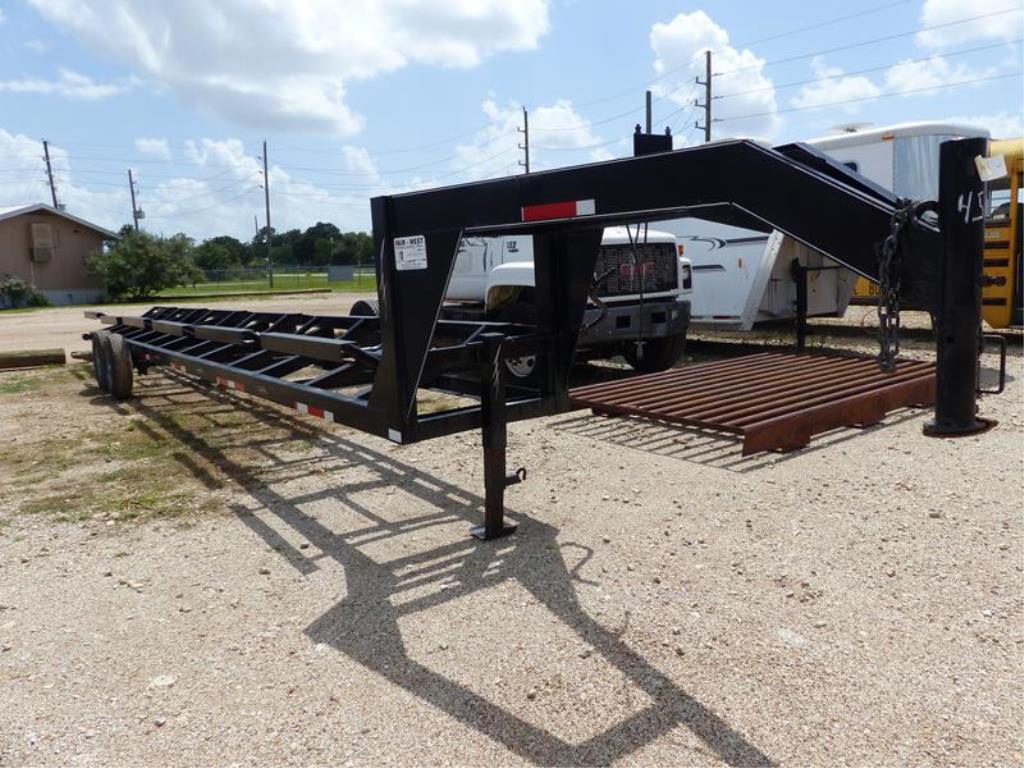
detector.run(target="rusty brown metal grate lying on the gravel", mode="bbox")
[569,352,935,456]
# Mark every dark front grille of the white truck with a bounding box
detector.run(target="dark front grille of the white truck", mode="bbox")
[594,243,679,297]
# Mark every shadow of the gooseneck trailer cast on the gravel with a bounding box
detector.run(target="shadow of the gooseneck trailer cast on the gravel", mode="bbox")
[103,375,775,766]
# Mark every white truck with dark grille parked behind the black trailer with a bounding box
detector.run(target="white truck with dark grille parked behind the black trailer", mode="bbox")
[446,225,692,380]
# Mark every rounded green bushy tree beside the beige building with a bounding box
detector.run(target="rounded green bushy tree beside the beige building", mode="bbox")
[86,229,203,299]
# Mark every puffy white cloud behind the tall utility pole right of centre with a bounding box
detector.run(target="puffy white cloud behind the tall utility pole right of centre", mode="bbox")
[650,10,780,140]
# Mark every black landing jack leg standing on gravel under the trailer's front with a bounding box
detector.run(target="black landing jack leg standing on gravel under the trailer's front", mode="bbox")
[471,334,521,541]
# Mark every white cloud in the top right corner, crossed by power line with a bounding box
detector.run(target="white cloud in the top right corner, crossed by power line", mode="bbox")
[915,0,1024,48]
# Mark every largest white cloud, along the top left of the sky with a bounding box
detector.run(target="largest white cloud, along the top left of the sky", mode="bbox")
[25,0,548,134]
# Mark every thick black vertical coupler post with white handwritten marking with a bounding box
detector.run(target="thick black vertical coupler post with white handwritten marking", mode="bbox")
[924,138,995,437]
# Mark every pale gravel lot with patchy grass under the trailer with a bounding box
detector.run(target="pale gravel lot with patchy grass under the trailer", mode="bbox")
[0,297,1024,766]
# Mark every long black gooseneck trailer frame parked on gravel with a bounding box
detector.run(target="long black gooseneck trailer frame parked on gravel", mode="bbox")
[88,134,990,539]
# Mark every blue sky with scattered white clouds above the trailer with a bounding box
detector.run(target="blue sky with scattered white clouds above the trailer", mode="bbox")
[0,0,1024,238]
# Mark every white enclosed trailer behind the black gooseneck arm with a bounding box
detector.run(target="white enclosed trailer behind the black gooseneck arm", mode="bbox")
[684,123,988,331]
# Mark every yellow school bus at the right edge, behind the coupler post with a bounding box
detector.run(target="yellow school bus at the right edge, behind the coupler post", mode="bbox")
[853,138,1024,328]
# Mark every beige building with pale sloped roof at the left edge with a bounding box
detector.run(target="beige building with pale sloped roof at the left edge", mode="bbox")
[0,203,117,304]
